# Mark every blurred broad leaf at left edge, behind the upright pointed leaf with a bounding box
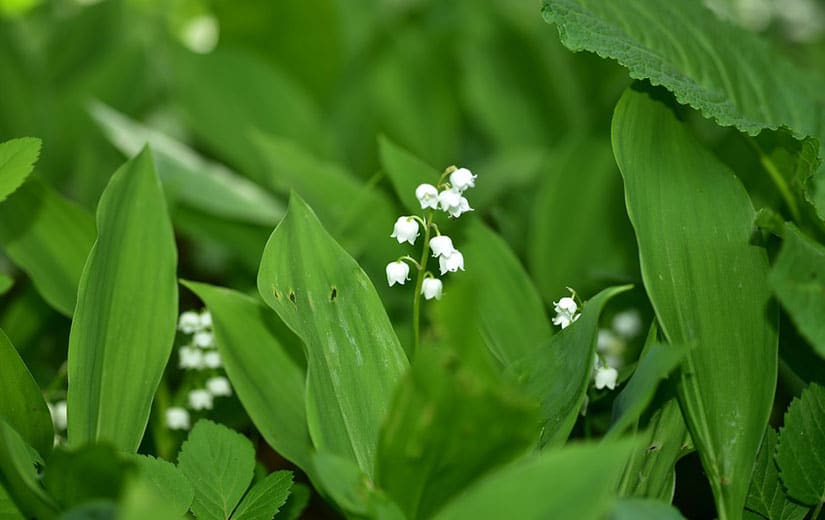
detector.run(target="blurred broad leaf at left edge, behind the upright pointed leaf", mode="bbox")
[0,179,95,316]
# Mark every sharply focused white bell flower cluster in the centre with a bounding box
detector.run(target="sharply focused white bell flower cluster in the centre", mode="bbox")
[386,166,476,300]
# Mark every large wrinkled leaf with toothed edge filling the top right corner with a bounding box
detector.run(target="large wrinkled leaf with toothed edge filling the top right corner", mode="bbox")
[544,0,825,139]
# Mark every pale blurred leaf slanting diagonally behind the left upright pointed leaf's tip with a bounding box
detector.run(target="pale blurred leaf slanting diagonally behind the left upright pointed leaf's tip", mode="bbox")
[89,102,286,226]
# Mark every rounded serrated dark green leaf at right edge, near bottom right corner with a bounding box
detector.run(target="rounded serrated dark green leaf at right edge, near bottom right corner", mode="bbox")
[776,383,825,505]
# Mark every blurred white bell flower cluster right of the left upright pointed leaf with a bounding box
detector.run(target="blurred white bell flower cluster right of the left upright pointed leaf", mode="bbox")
[166,310,232,430]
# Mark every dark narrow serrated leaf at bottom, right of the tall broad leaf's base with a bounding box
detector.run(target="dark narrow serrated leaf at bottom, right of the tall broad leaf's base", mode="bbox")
[745,427,808,520]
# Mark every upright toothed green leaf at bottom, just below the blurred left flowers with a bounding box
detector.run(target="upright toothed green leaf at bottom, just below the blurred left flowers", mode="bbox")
[178,419,255,520]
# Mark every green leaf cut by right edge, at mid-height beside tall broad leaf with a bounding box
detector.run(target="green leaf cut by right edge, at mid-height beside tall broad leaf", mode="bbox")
[769,224,825,358]
